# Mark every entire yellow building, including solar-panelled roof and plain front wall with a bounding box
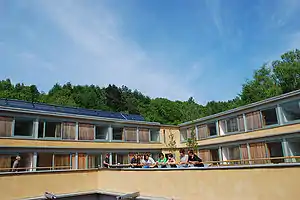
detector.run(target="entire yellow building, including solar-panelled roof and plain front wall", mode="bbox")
[0,90,300,200]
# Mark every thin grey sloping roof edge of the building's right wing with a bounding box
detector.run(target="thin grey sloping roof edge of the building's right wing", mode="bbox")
[179,90,300,126]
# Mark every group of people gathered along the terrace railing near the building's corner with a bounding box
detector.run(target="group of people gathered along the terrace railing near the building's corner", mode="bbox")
[103,149,204,168]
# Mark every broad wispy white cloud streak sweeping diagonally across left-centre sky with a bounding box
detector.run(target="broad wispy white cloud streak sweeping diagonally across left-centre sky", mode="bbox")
[29,1,193,100]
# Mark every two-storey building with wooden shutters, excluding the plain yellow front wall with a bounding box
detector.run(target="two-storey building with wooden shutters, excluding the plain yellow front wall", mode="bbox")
[0,90,300,171]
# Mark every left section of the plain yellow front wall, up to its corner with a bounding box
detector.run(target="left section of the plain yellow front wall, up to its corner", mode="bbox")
[0,171,98,200]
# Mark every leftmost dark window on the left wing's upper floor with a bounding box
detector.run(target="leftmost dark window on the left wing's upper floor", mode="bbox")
[14,118,33,136]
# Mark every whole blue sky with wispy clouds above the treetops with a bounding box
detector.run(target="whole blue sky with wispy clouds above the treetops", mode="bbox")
[0,0,300,103]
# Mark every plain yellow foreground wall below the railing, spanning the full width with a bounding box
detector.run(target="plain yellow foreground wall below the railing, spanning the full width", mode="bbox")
[0,167,300,200]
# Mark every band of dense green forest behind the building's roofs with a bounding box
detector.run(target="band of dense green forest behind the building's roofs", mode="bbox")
[0,49,300,124]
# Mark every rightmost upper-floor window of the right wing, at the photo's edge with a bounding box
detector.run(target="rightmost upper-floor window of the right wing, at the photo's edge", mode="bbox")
[281,101,300,122]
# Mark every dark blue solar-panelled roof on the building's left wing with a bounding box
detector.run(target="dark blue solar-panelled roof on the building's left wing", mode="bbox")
[0,98,145,122]
